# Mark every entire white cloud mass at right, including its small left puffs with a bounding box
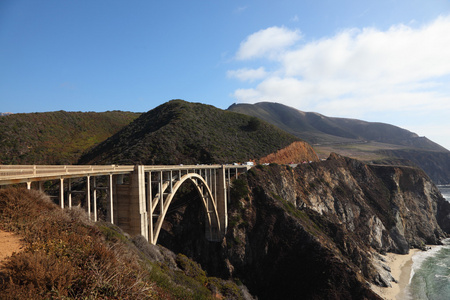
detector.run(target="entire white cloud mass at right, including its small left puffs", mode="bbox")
[229,17,450,115]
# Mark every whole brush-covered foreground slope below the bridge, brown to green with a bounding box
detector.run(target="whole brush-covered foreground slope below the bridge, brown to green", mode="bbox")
[0,188,243,299]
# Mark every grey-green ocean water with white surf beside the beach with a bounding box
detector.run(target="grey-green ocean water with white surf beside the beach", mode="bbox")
[406,185,450,300]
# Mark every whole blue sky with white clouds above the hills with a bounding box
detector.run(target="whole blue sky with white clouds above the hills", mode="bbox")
[0,0,450,149]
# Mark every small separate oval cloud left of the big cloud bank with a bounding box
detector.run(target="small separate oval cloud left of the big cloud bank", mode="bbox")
[236,27,301,60]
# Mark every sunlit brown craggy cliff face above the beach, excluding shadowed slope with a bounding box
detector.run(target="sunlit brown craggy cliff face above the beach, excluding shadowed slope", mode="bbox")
[272,154,445,253]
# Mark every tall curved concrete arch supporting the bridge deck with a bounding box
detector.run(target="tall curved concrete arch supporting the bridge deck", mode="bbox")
[149,173,221,245]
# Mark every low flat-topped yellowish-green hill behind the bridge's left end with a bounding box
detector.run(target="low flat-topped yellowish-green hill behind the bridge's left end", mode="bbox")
[0,111,139,164]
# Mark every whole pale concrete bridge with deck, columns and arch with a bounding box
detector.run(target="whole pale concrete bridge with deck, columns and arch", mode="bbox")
[0,165,250,244]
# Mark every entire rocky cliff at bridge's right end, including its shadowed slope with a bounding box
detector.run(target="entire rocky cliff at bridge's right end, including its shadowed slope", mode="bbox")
[160,154,450,299]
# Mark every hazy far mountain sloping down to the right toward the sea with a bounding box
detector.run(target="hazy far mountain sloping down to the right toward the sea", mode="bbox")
[228,102,450,184]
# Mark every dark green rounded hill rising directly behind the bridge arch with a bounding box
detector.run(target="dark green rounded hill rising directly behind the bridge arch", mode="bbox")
[79,100,317,164]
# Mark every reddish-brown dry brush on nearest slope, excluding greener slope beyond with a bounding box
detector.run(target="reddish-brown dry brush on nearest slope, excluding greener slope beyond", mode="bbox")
[0,189,154,299]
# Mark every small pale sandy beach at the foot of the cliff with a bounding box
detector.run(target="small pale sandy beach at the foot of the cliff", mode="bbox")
[372,249,420,300]
